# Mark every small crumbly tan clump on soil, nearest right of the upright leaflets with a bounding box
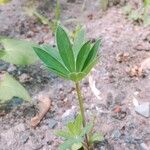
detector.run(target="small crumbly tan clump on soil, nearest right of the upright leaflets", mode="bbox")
[116,52,129,63]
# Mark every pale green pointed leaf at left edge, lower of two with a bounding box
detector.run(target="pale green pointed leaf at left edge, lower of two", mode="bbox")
[0,73,31,103]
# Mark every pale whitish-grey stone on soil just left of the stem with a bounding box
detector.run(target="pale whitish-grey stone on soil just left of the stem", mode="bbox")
[62,108,76,125]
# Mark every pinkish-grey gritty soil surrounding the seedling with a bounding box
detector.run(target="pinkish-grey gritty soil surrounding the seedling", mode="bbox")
[0,0,150,150]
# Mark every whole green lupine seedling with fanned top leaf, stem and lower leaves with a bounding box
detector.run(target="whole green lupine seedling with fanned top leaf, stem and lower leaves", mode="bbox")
[34,26,100,150]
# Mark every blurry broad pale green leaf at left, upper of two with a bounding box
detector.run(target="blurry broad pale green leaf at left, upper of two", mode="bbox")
[0,38,38,65]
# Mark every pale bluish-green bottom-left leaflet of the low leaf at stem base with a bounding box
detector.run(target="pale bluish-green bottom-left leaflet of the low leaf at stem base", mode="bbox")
[59,137,83,150]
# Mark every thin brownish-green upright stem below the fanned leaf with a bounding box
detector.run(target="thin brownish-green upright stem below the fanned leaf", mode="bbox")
[75,82,89,150]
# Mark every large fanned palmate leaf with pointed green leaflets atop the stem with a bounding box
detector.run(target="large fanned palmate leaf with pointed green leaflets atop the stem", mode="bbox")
[34,26,100,82]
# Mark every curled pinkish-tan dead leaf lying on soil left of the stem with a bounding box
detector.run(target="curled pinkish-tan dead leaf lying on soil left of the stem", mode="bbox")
[31,95,51,127]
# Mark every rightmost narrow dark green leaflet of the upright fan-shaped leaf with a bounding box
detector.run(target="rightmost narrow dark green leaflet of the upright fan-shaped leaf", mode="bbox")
[82,40,100,71]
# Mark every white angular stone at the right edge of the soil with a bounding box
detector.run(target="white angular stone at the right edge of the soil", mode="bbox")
[135,102,150,117]
